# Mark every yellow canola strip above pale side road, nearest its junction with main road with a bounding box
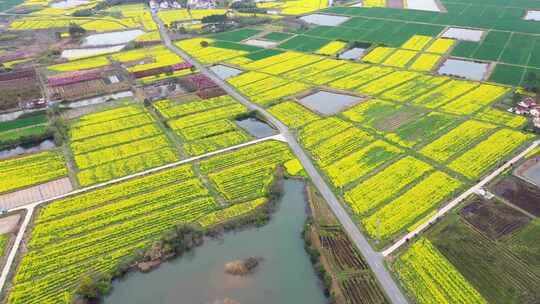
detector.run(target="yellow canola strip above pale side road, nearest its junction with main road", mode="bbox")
[362,172,462,239]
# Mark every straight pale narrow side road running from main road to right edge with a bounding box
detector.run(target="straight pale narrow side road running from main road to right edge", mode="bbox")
[382,140,540,256]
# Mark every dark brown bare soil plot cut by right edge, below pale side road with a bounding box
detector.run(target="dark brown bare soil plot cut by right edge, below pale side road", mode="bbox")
[492,176,540,216]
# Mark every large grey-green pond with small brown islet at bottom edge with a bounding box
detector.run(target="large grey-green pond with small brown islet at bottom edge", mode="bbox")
[104,180,326,304]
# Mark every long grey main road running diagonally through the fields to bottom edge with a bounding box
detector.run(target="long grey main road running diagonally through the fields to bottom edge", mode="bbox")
[153,15,407,304]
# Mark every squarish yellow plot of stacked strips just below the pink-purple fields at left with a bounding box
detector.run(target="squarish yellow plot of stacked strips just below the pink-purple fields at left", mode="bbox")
[70,106,178,186]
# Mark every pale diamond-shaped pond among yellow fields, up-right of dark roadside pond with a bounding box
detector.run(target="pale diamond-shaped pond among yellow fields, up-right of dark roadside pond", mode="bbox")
[300,91,364,115]
